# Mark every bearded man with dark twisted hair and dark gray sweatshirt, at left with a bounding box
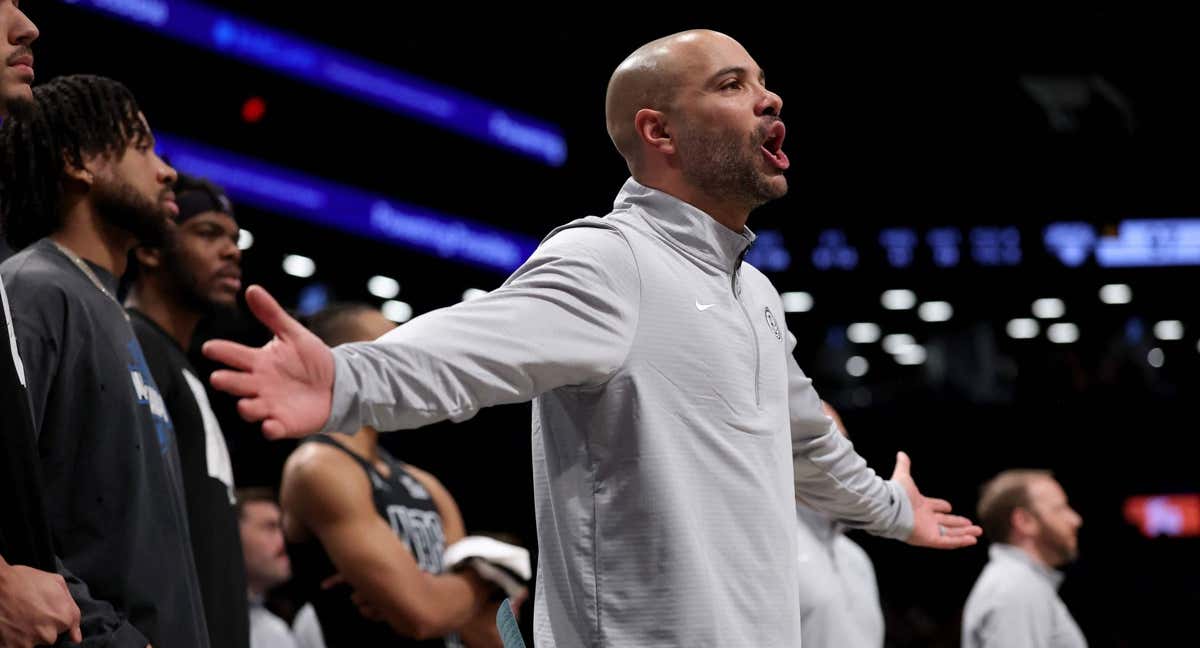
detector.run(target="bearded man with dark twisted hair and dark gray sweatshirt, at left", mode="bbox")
[0,76,209,648]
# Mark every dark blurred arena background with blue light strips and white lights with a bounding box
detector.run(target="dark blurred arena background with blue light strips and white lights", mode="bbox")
[22,0,1200,647]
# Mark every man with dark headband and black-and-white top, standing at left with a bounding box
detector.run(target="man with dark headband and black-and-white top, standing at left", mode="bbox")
[125,175,250,648]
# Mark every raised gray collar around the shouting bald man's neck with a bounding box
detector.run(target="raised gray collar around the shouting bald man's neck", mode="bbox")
[613,178,755,274]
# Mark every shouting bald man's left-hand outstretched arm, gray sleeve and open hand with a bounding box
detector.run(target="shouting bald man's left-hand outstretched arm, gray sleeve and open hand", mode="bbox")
[204,227,641,438]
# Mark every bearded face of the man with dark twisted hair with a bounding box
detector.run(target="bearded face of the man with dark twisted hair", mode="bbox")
[85,113,179,246]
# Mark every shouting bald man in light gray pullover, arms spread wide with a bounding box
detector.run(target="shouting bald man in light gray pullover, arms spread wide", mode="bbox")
[205,31,980,648]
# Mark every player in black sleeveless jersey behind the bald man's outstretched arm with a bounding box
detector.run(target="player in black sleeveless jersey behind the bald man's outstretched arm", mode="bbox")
[281,305,525,648]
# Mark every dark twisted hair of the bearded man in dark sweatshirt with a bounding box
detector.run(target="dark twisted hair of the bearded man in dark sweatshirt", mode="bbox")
[0,74,152,250]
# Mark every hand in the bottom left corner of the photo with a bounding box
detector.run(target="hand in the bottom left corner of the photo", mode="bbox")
[0,560,83,648]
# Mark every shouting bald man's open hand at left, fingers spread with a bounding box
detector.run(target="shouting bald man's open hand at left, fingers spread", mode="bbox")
[202,286,334,439]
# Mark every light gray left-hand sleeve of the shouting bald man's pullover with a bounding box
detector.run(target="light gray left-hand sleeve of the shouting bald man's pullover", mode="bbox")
[324,227,641,431]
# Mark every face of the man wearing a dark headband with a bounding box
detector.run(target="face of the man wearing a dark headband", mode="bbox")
[163,211,241,311]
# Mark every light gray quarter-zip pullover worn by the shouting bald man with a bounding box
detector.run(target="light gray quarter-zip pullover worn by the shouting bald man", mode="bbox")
[325,180,912,648]
